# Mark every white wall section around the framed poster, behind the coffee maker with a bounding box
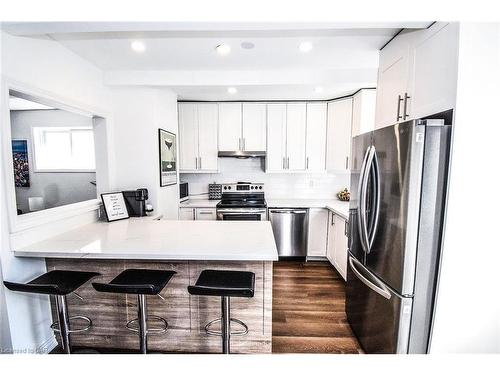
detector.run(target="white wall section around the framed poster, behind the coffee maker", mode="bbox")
[113,88,179,219]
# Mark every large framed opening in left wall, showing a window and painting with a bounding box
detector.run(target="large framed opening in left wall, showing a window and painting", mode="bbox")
[9,90,99,215]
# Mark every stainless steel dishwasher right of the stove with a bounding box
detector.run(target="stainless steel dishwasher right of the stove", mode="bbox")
[269,208,309,257]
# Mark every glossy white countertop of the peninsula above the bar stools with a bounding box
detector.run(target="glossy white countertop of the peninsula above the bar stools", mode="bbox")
[14,220,278,261]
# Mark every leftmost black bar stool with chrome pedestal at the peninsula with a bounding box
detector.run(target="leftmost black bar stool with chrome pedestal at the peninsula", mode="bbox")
[3,270,100,354]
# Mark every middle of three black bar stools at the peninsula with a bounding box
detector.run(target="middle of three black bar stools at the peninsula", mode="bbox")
[92,269,176,354]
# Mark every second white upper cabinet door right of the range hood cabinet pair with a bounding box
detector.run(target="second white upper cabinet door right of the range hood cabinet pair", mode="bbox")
[286,103,306,171]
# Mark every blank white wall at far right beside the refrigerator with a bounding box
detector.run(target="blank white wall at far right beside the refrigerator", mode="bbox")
[431,23,500,353]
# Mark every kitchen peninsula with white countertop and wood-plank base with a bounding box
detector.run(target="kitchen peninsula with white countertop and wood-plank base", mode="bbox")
[14,219,278,353]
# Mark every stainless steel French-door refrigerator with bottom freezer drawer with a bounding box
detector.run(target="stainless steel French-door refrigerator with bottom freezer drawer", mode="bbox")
[346,120,451,353]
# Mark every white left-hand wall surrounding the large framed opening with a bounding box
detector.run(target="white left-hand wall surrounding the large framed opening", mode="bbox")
[0,32,112,351]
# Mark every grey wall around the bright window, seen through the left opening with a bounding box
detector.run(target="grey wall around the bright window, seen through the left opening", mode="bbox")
[10,110,97,213]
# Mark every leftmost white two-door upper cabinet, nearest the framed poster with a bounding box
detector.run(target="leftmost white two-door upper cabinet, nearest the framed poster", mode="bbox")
[179,103,218,173]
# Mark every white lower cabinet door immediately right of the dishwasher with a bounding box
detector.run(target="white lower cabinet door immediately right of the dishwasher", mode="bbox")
[307,208,329,257]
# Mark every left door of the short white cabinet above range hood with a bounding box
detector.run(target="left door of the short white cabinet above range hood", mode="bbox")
[219,103,242,151]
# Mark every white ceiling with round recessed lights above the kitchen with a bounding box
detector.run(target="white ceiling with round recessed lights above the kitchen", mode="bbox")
[3,22,430,100]
